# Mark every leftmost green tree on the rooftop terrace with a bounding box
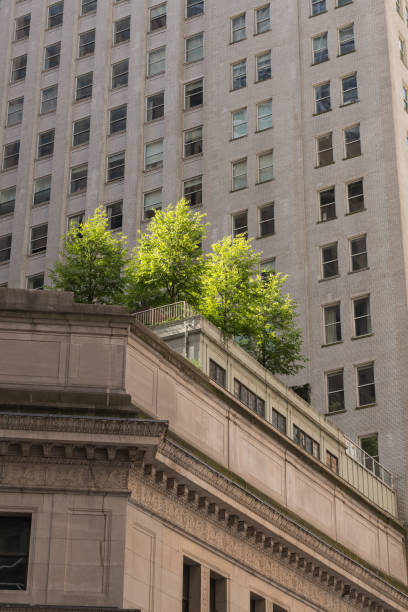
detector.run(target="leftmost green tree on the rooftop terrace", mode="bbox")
[49,206,128,304]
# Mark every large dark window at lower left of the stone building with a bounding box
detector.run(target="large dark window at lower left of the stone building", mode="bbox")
[0,515,31,591]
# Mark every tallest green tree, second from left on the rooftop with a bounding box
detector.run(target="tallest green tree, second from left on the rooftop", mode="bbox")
[125,200,207,310]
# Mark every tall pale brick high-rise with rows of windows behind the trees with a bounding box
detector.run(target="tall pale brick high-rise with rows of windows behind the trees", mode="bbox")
[0,0,408,517]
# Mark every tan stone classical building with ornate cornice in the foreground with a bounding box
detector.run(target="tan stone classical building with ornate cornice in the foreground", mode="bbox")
[0,289,408,612]
